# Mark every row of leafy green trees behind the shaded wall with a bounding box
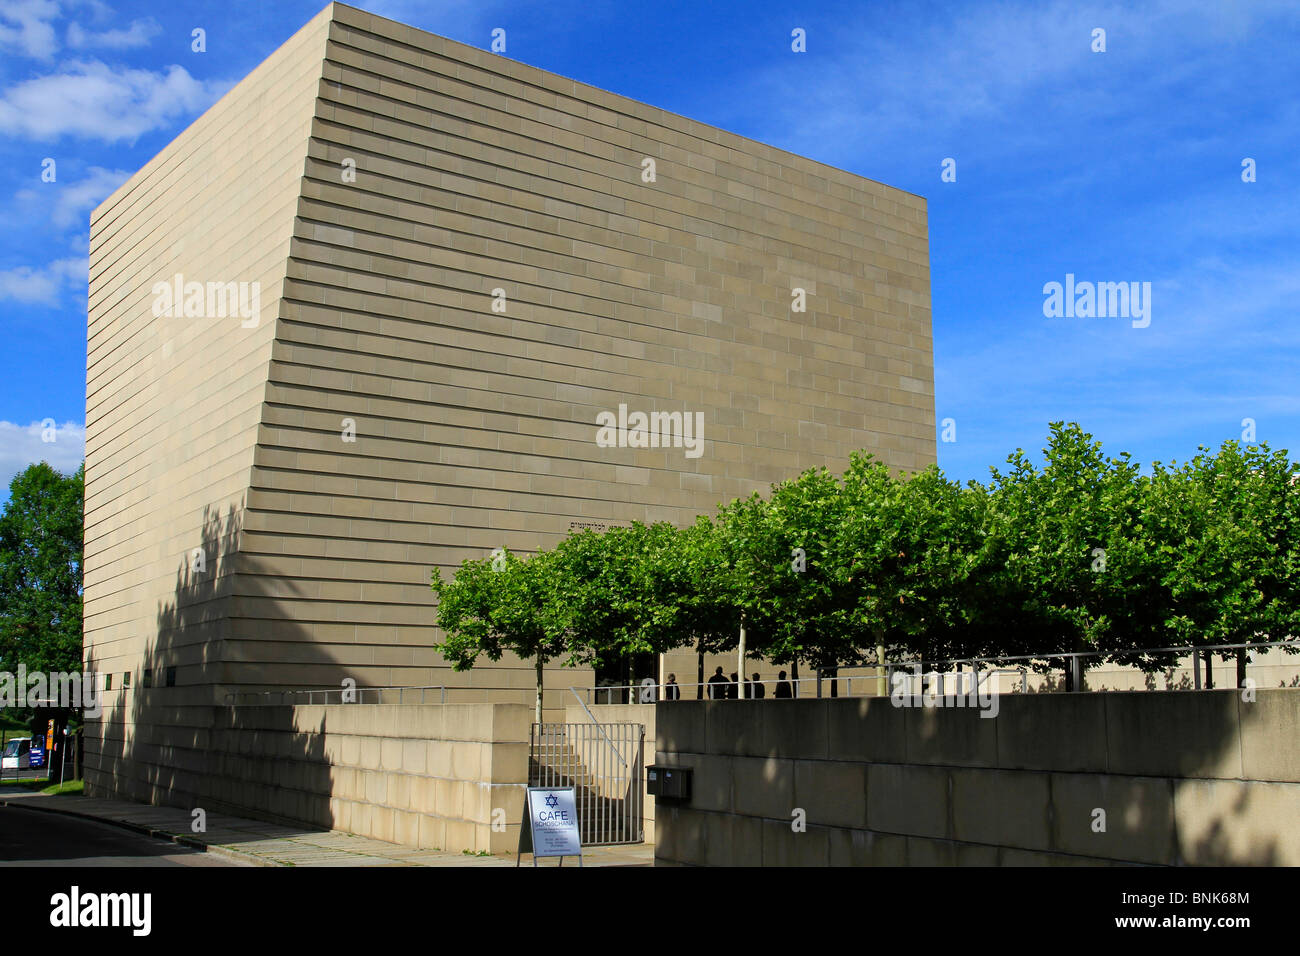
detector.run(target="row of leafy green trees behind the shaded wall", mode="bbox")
[433,423,1300,723]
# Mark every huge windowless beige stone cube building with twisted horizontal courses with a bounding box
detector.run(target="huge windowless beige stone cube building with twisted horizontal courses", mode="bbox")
[85,4,935,799]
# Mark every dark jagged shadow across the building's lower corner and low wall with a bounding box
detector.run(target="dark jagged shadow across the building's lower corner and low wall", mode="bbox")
[86,502,335,842]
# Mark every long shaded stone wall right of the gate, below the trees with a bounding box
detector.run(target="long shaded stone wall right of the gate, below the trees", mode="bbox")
[655,689,1300,866]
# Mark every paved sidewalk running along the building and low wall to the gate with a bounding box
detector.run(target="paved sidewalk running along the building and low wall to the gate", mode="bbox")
[0,792,654,866]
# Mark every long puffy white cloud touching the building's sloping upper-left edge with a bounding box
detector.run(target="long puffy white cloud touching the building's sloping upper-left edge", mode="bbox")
[0,60,229,143]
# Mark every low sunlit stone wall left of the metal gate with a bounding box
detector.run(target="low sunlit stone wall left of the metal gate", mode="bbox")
[87,704,532,853]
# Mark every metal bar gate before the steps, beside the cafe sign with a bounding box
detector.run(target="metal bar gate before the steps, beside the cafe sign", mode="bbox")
[528,723,646,847]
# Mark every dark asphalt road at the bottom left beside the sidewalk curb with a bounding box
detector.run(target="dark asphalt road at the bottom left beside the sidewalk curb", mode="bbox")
[0,806,239,866]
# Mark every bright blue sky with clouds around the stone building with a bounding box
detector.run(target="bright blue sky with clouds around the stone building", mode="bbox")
[0,0,1300,486]
